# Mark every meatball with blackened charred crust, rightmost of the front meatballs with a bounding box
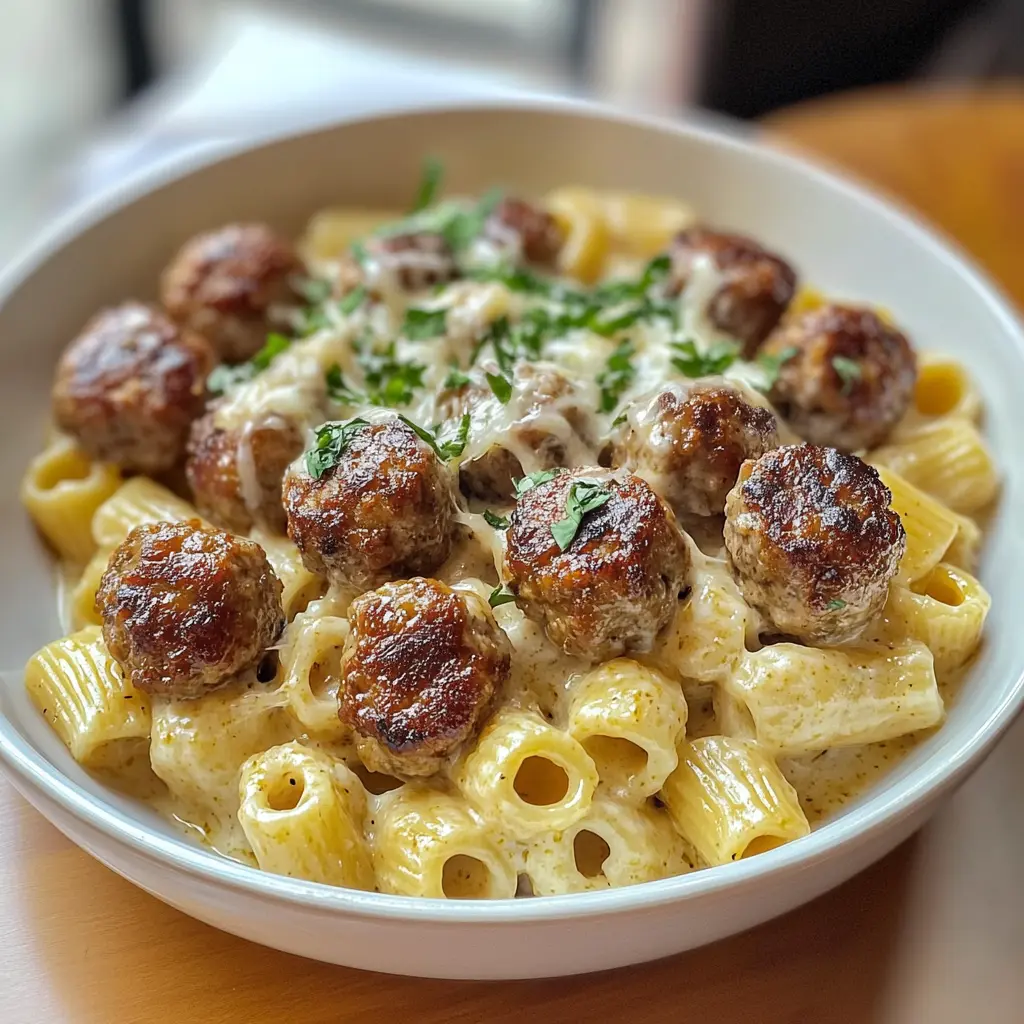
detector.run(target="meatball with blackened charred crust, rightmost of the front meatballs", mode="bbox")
[725,444,906,644]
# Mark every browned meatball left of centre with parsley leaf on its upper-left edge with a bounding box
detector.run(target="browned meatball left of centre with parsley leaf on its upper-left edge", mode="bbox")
[284,419,455,590]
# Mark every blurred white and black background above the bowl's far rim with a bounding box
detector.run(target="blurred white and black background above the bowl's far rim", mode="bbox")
[0,0,1024,261]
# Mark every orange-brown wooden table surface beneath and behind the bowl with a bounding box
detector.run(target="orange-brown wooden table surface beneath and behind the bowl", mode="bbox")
[0,89,1024,1024]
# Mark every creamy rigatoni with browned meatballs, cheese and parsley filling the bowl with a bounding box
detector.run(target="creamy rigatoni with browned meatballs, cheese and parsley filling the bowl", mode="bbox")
[23,155,998,899]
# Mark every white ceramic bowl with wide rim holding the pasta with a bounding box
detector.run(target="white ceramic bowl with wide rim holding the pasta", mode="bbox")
[0,99,1024,978]
